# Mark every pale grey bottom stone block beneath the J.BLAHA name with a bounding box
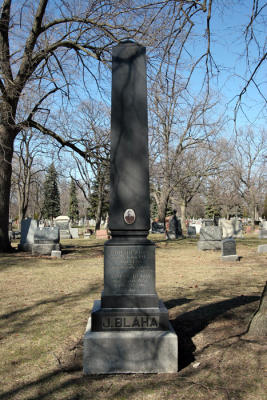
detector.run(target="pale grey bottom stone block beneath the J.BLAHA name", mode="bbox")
[83,318,178,375]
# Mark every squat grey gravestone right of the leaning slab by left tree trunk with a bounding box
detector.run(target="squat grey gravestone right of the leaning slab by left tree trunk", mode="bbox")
[32,227,60,255]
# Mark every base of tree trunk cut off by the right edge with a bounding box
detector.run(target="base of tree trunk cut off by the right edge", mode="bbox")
[248,282,267,336]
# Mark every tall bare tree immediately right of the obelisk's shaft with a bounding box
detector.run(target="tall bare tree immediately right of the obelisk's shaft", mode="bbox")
[151,77,221,222]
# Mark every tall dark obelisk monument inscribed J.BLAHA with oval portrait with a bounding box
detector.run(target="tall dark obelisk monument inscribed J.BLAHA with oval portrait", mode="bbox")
[83,41,178,374]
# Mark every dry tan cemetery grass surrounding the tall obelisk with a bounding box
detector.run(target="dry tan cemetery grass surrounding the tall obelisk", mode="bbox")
[0,235,267,400]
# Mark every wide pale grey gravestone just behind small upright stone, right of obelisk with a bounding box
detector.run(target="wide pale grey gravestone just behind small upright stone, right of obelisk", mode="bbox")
[197,226,222,250]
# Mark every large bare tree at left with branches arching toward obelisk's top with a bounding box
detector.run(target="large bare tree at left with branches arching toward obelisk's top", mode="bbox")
[0,0,214,251]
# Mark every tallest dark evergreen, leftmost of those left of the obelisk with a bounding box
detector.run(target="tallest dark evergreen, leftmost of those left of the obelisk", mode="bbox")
[42,163,60,219]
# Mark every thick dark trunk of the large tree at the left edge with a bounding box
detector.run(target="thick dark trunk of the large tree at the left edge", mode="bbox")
[0,125,14,252]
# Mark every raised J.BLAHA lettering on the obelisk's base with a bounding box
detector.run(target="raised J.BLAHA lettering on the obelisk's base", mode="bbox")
[102,316,159,329]
